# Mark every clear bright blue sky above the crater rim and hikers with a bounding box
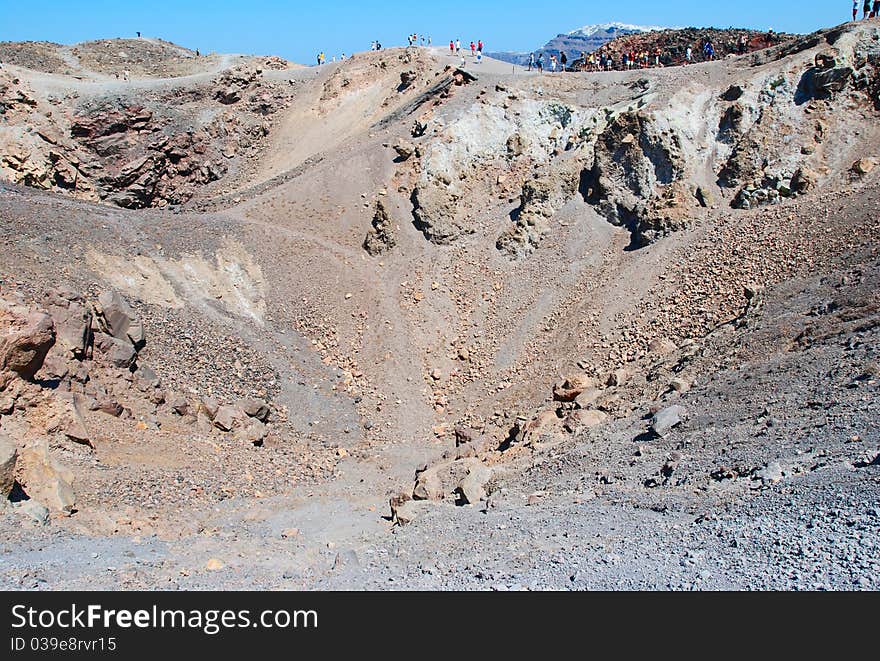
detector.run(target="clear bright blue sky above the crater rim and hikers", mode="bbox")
[0,0,852,63]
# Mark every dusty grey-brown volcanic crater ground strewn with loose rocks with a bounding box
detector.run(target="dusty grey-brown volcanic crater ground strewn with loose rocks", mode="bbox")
[0,22,880,589]
